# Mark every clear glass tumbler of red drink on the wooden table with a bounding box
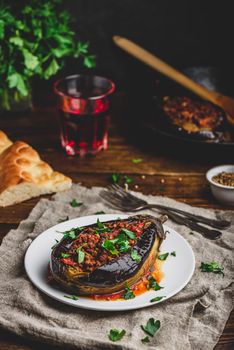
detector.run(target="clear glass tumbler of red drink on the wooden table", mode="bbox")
[55,75,115,156]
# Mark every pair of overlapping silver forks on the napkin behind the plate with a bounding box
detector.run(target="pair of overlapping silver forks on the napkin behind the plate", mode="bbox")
[100,185,230,239]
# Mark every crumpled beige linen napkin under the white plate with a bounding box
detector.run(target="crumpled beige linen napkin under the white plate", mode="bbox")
[0,185,234,350]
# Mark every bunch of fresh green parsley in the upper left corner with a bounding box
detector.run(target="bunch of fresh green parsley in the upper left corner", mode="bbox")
[0,0,95,110]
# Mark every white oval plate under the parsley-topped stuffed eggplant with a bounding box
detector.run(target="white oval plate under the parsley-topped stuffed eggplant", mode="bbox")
[24,214,195,311]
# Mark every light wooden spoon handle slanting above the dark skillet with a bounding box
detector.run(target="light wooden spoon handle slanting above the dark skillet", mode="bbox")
[113,35,217,103]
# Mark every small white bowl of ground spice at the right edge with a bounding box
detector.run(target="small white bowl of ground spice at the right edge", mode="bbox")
[206,164,234,206]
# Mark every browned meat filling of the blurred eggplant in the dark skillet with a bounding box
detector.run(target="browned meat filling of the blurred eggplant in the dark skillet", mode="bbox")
[163,97,224,133]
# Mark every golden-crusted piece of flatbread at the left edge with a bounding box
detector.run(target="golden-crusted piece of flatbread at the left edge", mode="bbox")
[0,131,72,207]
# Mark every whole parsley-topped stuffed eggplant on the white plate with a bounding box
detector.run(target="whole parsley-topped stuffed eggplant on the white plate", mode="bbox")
[50,215,165,295]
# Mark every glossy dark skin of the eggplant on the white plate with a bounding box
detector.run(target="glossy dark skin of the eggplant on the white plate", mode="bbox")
[50,215,165,295]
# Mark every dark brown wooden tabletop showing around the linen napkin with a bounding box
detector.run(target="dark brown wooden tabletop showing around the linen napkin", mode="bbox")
[0,100,234,350]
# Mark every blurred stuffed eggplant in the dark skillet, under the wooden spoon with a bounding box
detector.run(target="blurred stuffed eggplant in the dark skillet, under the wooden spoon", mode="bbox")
[162,96,226,142]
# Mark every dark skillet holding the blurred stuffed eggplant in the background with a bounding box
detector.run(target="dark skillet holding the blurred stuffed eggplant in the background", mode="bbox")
[143,67,234,151]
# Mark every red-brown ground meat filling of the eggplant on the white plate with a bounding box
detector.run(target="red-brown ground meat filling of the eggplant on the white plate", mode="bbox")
[61,222,144,272]
